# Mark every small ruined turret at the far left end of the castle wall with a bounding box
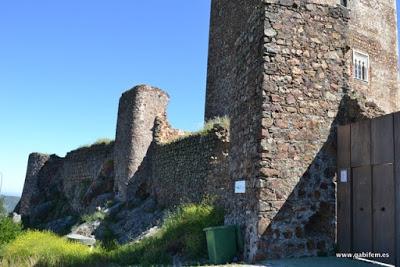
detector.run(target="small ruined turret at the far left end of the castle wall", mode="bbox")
[17,153,50,216]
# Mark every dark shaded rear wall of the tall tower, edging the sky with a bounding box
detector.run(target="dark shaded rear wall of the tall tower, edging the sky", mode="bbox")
[205,0,260,120]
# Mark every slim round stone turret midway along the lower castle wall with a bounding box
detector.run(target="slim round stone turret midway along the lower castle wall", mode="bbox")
[114,85,169,200]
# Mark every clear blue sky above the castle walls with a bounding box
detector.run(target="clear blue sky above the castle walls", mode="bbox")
[0,0,210,195]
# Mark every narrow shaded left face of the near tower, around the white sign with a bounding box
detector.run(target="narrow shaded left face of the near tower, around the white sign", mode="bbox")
[225,3,264,259]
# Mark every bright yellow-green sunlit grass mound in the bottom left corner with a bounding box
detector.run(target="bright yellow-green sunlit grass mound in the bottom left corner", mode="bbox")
[1,231,100,266]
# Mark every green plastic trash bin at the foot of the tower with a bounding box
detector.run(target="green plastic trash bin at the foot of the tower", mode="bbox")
[204,225,238,264]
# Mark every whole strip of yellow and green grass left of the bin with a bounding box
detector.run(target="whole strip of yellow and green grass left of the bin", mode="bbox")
[0,202,224,266]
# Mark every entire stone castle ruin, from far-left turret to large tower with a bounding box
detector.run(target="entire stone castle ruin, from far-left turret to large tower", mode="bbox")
[17,0,400,262]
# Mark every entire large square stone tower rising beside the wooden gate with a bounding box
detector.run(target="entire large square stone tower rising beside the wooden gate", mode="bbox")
[205,0,400,261]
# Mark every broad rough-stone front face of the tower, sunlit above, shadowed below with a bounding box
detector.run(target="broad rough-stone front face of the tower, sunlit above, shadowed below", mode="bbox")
[255,0,381,259]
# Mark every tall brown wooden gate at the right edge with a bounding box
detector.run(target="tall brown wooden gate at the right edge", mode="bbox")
[337,113,400,266]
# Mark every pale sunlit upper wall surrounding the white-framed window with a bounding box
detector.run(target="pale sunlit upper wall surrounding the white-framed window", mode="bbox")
[348,0,400,113]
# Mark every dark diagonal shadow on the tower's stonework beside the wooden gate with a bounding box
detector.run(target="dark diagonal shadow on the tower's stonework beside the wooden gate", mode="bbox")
[257,91,382,259]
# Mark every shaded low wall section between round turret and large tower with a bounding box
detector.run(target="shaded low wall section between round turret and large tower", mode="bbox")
[150,126,233,208]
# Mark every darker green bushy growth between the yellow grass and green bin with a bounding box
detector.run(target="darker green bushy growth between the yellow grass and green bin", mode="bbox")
[109,203,224,265]
